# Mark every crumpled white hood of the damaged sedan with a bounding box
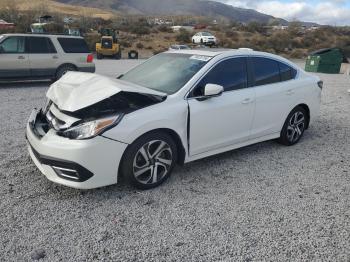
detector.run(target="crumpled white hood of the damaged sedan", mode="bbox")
[46,72,166,112]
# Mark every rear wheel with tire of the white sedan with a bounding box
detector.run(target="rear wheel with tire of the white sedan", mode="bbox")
[278,106,309,146]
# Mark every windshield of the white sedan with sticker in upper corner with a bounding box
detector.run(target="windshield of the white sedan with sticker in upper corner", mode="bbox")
[120,53,211,94]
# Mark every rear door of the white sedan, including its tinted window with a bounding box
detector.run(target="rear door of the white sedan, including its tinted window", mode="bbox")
[249,57,296,139]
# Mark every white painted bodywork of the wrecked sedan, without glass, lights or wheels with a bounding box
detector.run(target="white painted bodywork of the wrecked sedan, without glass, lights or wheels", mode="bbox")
[27,50,321,189]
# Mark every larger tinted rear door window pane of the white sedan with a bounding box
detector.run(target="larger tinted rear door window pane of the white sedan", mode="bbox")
[252,57,281,86]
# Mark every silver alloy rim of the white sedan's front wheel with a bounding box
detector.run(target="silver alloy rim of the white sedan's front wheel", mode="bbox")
[133,140,173,185]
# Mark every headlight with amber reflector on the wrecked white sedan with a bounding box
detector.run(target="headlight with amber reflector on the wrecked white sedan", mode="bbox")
[59,114,123,140]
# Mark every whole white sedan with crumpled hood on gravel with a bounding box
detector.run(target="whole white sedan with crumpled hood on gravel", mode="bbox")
[26,49,322,189]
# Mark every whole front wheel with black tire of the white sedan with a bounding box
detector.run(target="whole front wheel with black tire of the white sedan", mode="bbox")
[120,131,177,190]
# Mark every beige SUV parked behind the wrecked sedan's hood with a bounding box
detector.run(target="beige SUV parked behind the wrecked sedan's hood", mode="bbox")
[0,34,95,80]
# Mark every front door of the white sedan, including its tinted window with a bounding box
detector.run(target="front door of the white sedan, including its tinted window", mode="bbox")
[188,57,255,156]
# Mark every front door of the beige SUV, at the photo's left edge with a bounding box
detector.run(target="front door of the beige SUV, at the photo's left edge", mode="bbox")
[0,36,30,79]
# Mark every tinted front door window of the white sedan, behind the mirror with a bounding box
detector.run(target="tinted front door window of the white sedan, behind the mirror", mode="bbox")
[193,57,247,96]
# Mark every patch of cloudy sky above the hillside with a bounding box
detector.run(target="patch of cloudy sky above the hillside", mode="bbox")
[217,0,350,26]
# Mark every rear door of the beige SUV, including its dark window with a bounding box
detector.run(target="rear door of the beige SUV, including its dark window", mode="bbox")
[27,36,59,77]
